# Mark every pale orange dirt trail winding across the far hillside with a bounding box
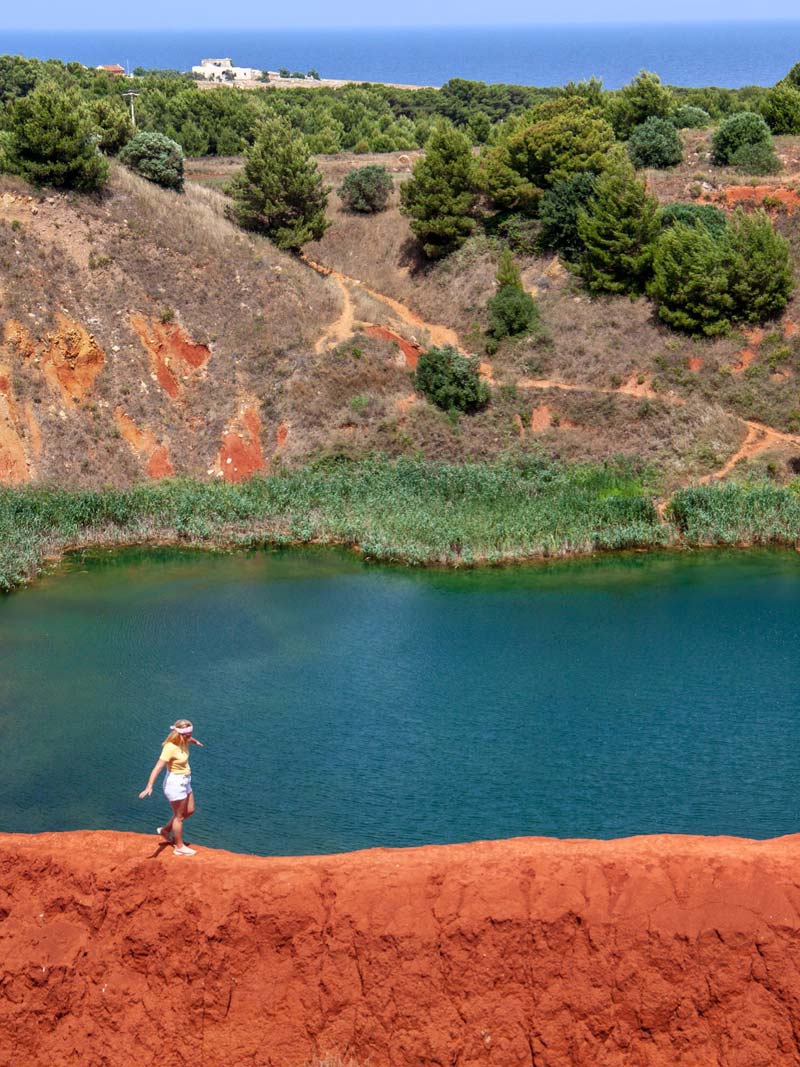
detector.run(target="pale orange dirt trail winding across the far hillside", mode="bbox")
[300,254,800,484]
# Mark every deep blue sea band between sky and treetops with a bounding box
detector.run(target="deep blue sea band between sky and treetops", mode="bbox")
[0,20,800,89]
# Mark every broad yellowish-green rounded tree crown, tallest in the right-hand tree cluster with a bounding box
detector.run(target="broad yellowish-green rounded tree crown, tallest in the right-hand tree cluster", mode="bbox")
[483,96,614,214]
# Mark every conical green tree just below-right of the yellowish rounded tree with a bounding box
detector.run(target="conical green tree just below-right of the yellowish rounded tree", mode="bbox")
[578,152,659,293]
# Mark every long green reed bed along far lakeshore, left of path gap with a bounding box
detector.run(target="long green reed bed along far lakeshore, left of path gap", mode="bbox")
[0,458,670,590]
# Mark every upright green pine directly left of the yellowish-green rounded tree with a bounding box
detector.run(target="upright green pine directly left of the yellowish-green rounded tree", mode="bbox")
[400,124,478,259]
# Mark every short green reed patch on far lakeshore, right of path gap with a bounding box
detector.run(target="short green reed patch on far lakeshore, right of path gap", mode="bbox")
[669,479,800,545]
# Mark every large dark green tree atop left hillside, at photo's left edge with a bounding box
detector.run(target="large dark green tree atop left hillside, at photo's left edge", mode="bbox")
[6,82,109,192]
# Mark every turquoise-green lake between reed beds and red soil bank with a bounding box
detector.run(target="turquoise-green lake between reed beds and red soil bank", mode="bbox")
[0,551,800,855]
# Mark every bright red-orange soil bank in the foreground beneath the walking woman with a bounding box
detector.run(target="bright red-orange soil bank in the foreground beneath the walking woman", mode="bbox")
[0,832,800,1067]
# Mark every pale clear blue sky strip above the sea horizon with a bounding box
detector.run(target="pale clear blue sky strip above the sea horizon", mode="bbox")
[0,0,798,29]
